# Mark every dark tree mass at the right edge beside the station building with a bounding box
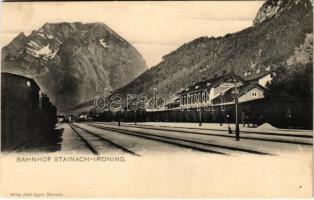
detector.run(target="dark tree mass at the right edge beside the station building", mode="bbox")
[265,64,313,128]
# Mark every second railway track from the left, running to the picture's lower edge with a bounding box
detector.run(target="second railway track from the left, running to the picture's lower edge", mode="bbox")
[86,123,271,155]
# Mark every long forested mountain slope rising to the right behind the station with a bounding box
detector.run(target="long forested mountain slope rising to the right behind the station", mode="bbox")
[116,0,313,99]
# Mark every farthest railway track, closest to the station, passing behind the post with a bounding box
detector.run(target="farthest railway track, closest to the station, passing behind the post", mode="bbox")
[88,123,313,146]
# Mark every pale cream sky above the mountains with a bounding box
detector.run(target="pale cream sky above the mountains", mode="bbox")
[1,1,263,67]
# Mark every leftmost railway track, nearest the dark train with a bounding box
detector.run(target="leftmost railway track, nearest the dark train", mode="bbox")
[69,124,140,156]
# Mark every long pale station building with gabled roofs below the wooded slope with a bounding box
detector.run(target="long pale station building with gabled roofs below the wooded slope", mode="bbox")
[148,70,275,123]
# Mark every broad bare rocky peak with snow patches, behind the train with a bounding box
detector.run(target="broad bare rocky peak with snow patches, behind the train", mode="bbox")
[1,23,147,110]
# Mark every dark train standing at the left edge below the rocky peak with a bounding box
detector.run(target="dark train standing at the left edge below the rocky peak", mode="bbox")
[1,72,57,151]
